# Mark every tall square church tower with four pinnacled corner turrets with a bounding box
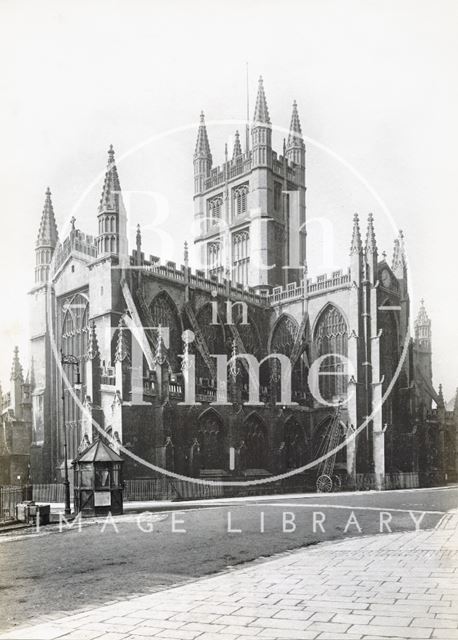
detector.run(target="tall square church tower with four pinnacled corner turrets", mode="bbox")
[194,77,305,291]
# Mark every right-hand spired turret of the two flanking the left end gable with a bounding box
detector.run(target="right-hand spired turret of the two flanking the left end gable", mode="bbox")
[97,145,127,258]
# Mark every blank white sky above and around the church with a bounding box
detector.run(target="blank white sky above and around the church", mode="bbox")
[0,0,458,399]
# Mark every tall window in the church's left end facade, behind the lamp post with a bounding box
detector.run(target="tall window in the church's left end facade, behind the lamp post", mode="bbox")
[60,293,89,460]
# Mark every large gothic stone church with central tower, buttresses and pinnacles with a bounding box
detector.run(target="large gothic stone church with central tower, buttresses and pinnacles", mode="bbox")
[30,79,455,488]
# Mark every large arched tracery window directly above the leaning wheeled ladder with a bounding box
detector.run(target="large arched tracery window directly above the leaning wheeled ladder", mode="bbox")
[315,305,348,402]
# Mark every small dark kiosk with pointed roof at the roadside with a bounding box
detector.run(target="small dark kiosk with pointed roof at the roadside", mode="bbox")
[73,439,124,517]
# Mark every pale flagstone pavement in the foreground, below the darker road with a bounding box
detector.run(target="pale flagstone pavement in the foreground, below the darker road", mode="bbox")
[0,510,458,640]
